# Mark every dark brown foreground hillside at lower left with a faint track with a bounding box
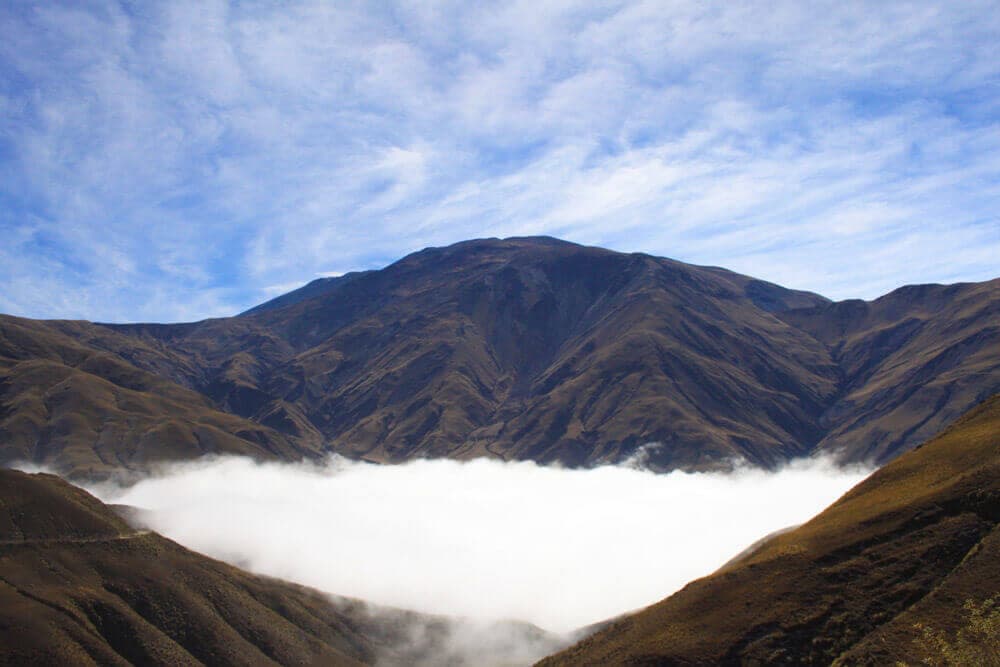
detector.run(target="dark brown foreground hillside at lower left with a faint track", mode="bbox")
[0,470,565,667]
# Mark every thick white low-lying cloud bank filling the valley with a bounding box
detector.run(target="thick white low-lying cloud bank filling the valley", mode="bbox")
[90,458,869,632]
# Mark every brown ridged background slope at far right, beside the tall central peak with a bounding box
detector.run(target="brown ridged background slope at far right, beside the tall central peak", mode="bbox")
[779,280,1000,463]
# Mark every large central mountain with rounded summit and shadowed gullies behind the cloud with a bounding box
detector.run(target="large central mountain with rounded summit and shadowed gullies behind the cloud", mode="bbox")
[99,239,837,465]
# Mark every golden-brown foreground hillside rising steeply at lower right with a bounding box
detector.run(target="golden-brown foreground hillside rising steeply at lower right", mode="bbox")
[539,396,1000,667]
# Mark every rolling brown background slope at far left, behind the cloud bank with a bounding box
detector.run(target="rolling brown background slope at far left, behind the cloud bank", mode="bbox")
[0,317,320,477]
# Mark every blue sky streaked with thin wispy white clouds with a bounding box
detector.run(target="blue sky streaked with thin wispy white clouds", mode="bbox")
[0,0,1000,321]
